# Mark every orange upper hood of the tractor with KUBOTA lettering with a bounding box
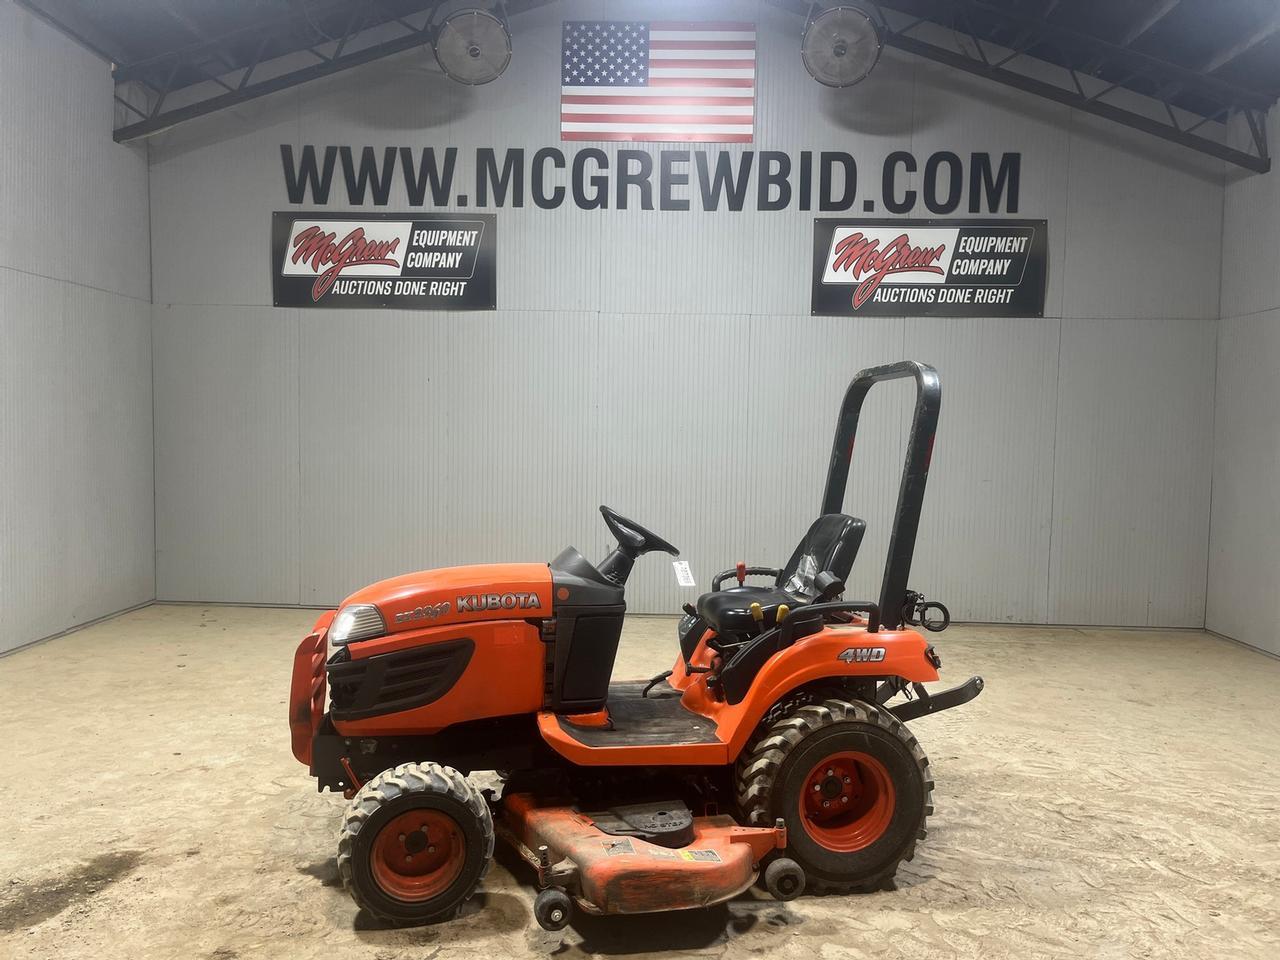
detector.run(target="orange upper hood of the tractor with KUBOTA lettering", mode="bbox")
[342,563,552,634]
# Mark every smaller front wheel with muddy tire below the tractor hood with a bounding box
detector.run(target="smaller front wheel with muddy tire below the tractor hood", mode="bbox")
[338,763,494,923]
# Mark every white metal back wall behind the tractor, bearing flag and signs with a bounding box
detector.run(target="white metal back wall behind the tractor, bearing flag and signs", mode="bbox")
[151,0,1222,626]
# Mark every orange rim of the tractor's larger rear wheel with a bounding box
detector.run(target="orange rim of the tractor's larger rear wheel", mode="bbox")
[800,751,896,854]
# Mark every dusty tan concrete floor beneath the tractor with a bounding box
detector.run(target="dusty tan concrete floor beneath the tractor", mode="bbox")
[0,605,1280,960]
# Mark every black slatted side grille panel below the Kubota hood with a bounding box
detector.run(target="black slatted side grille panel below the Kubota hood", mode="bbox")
[329,637,475,722]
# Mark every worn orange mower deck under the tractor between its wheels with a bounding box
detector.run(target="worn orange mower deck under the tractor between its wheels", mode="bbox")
[497,794,799,925]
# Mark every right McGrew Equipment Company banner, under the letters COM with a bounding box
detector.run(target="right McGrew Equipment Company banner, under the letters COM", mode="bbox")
[812,219,1048,316]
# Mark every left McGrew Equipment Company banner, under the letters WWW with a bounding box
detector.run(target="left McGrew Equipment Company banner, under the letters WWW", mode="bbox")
[271,211,497,310]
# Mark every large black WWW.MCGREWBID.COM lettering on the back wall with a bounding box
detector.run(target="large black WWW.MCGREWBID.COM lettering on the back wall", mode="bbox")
[280,143,1021,215]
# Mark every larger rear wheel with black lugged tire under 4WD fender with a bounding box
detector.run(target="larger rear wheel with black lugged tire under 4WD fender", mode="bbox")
[737,699,933,893]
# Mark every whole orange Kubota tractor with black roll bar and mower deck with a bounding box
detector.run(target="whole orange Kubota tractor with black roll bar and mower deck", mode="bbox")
[289,361,982,929]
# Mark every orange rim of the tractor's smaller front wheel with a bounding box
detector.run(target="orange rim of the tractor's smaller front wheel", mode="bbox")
[370,810,466,902]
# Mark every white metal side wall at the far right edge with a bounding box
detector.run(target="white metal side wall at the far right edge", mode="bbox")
[1208,110,1280,654]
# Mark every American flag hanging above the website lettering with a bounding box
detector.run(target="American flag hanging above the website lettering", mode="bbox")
[561,20,755,143]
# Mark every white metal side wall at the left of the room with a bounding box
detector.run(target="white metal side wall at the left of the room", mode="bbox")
[0,0,155,652]
